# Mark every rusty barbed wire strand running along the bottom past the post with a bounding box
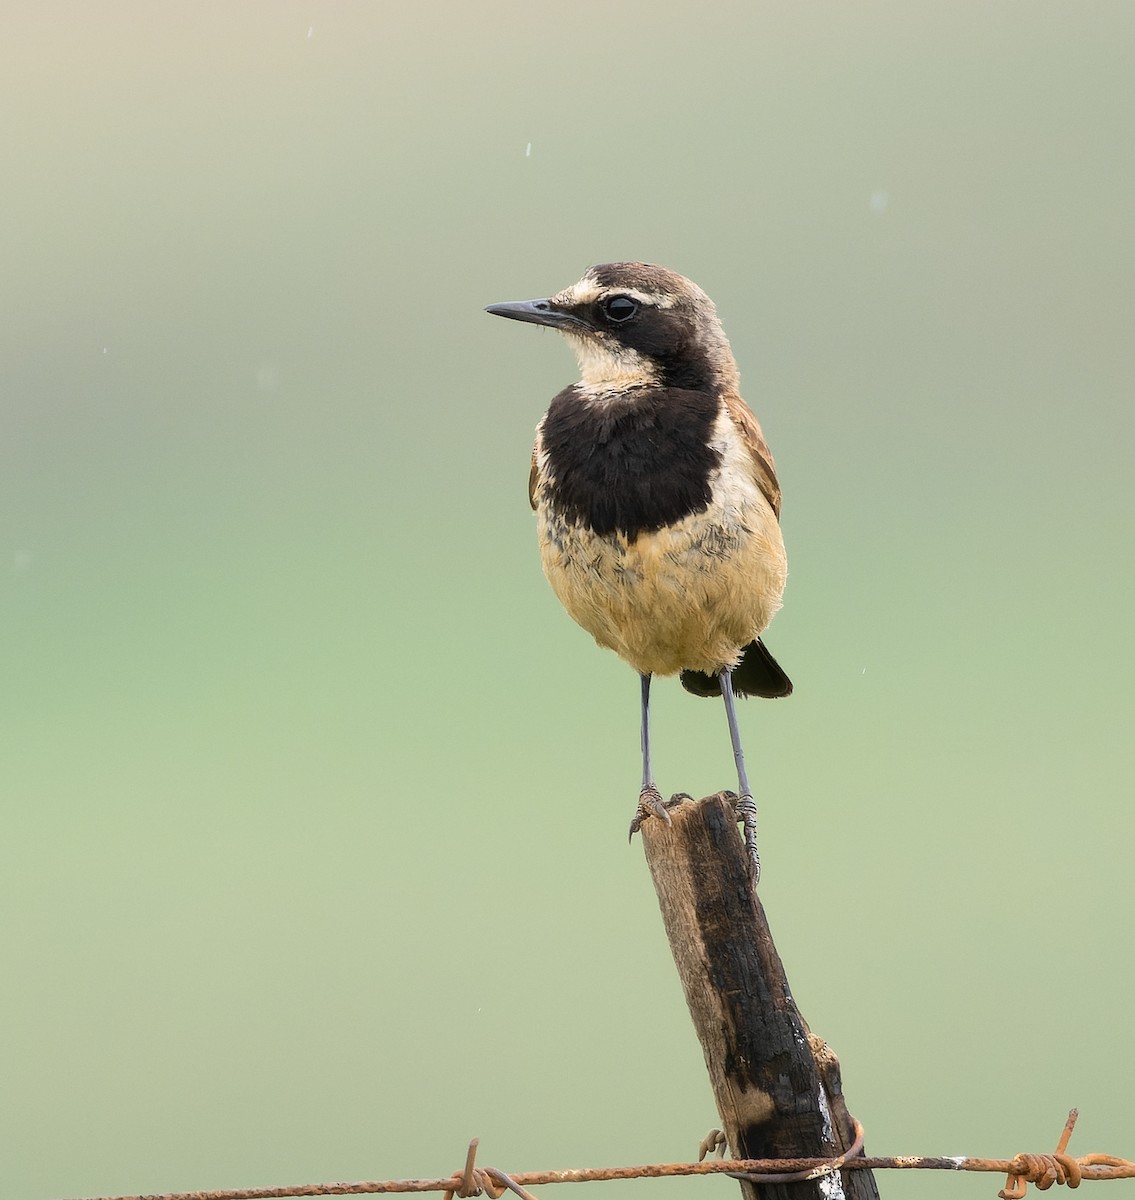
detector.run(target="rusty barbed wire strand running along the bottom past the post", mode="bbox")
[59,1109,1135,1200]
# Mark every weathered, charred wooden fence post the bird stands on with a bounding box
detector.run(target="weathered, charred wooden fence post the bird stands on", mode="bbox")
[642,792,878,1200]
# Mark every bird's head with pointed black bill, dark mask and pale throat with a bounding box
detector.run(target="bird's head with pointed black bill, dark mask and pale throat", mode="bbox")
[486,263,738,394]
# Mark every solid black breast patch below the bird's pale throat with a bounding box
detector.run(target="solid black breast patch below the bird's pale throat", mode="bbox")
[542,386,720,540]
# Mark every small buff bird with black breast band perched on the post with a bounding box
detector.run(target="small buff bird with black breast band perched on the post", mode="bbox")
[486,262,792,883]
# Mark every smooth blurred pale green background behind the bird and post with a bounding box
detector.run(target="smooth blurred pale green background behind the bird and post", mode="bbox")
[0,7,1135,1200]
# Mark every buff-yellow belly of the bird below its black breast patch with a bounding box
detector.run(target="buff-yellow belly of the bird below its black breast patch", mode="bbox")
[538,493,787,676]
